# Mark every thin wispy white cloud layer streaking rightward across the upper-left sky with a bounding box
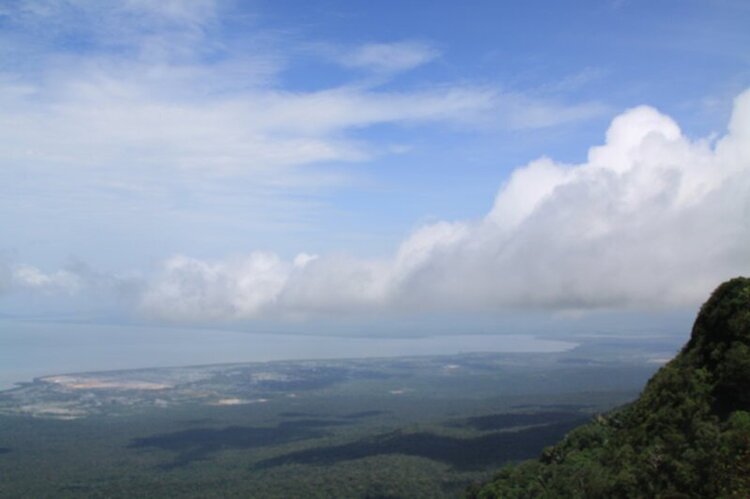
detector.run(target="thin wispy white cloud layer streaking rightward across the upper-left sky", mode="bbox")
[0,61,603,179]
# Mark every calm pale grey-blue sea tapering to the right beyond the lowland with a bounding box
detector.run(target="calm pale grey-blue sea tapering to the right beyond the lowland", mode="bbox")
[0,321,575,389]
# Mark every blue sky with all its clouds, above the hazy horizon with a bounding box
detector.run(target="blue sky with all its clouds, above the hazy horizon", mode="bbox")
[0,0,750,337]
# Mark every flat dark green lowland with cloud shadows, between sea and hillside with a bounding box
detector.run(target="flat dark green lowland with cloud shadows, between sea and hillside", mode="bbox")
[0,352,656,499]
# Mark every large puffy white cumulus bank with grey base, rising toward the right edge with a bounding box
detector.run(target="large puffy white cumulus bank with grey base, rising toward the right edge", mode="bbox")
[140,90,750,322]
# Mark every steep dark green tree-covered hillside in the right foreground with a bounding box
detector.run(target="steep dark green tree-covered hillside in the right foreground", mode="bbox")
[468,277,750,498]
